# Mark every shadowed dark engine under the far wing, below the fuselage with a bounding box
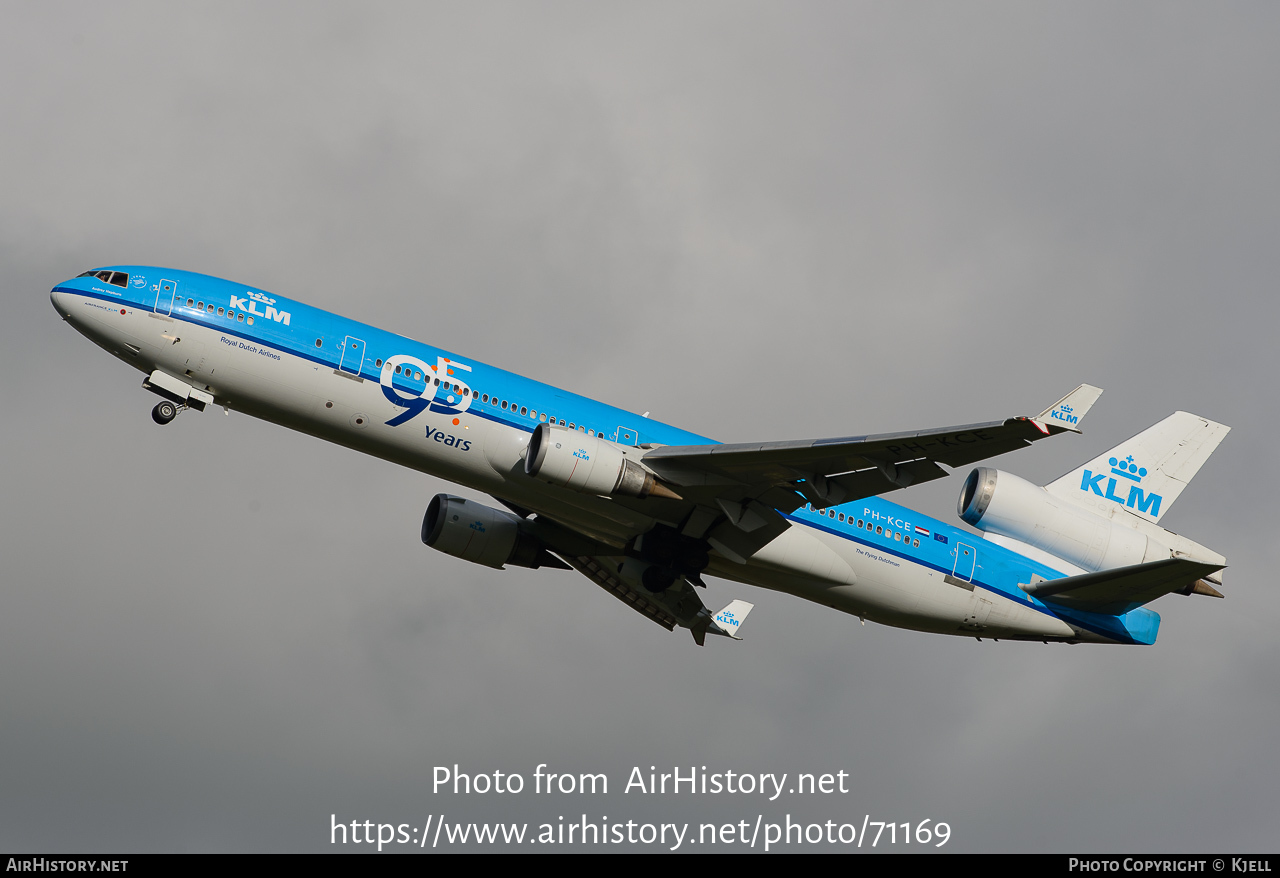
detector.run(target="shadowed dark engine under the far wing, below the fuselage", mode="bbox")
[422,494,550,570]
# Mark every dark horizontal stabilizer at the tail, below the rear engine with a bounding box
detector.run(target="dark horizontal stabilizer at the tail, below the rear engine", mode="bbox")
[1023,558,1222,616]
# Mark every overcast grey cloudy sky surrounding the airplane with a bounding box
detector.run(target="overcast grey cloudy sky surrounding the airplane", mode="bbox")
[0,1,1280,852]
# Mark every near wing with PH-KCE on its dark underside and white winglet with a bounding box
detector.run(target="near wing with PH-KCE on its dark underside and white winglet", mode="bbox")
[643,384,1102,562]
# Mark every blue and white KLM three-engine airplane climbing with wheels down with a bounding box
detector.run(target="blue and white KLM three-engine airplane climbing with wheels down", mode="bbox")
[50,265,1229,645]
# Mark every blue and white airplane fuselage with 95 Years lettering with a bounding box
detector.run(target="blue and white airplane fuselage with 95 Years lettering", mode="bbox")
[51,266,1160,644]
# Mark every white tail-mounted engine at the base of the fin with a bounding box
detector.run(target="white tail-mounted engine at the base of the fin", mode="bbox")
[957,466,1171,571]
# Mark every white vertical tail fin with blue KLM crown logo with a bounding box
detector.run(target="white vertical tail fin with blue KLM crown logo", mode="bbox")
[1044,412,1231,523]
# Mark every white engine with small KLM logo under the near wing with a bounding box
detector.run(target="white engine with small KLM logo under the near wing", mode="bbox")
[525,424,675,498]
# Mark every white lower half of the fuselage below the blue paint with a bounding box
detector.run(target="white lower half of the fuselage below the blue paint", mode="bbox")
[58,292,1112,643]
